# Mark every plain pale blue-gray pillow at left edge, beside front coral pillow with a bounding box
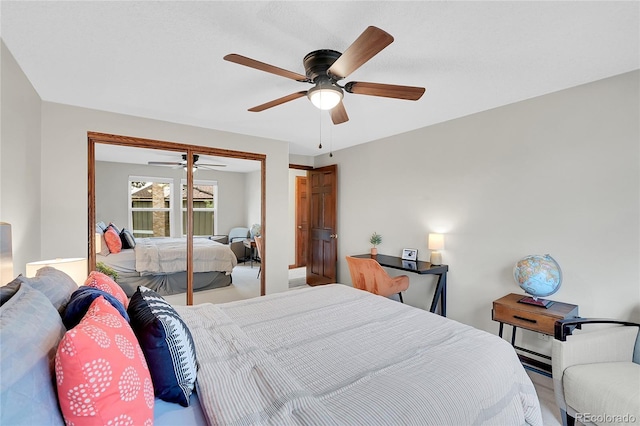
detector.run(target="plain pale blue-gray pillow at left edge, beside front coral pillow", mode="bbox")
[0,283,66,425]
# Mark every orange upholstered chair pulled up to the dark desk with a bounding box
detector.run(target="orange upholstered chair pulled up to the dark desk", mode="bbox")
[347,256,409,303]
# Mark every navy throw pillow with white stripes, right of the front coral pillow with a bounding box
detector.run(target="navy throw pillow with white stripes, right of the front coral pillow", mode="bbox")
[128,286,198,407]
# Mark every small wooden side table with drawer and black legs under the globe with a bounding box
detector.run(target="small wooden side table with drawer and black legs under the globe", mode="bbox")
[491,293,578,377]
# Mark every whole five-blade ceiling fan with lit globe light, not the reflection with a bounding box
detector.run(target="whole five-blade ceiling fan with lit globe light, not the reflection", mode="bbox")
[224,26,425,124]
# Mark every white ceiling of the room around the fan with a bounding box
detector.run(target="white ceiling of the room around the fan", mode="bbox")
[0,0,640,155]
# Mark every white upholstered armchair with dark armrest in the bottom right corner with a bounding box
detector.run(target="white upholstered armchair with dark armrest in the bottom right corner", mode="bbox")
[551,318,640,426]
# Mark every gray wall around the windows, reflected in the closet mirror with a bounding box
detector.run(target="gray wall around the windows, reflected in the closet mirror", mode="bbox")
[96,161,249,236]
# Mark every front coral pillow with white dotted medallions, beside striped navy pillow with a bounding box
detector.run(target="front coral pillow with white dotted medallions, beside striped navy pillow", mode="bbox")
[55,296,154,426]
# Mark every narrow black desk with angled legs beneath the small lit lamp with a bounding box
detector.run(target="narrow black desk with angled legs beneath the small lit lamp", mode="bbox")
[353,254,449,317]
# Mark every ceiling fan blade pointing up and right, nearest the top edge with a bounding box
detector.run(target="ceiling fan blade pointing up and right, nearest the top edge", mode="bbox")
[327,26,393,80]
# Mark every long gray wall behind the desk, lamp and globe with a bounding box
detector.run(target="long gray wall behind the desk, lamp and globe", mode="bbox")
[316,71,640,352]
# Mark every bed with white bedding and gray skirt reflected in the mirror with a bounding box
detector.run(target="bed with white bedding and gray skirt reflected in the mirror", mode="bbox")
[96,238,237,297]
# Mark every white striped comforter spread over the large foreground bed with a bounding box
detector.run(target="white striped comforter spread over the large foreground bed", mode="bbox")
[176,284,542,425]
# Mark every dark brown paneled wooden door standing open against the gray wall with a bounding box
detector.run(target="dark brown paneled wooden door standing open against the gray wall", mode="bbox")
[307,164,338,285]
